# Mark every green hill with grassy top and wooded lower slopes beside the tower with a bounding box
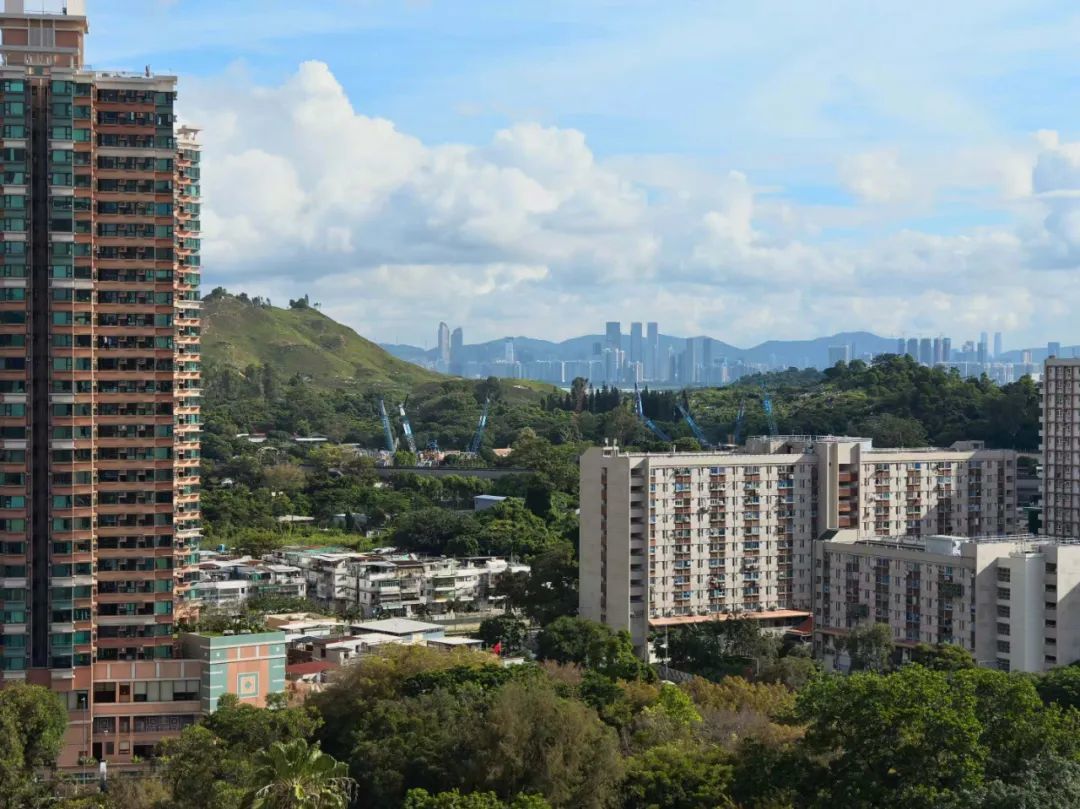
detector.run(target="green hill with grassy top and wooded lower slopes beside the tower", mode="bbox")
[202,288,567,458]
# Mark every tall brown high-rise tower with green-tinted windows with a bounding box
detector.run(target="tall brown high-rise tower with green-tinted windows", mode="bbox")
[0,0,200,764]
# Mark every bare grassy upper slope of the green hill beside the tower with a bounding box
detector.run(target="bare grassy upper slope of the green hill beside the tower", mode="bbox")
[202,289,445,390]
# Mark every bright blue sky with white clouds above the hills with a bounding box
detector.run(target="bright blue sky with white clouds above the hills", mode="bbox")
[86,0,1080,348]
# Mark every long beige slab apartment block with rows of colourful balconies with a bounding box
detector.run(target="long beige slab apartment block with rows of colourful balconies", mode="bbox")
[580,436,1017,648]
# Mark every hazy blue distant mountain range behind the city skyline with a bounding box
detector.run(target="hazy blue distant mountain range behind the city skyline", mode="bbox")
[382,332,896,368]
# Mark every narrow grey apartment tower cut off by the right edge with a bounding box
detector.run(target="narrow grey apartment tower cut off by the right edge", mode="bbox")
[1041,356,1080,539]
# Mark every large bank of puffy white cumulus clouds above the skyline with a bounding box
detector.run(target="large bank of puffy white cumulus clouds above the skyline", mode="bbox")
[183,62,1080,343]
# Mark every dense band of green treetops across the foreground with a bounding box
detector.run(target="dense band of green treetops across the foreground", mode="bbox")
[8,619,1080,809]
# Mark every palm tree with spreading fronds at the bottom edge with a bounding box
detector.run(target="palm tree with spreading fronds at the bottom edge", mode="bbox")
[244,739,356,809]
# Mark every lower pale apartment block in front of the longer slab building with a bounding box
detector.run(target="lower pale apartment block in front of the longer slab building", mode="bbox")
[813,530,1080,672]
